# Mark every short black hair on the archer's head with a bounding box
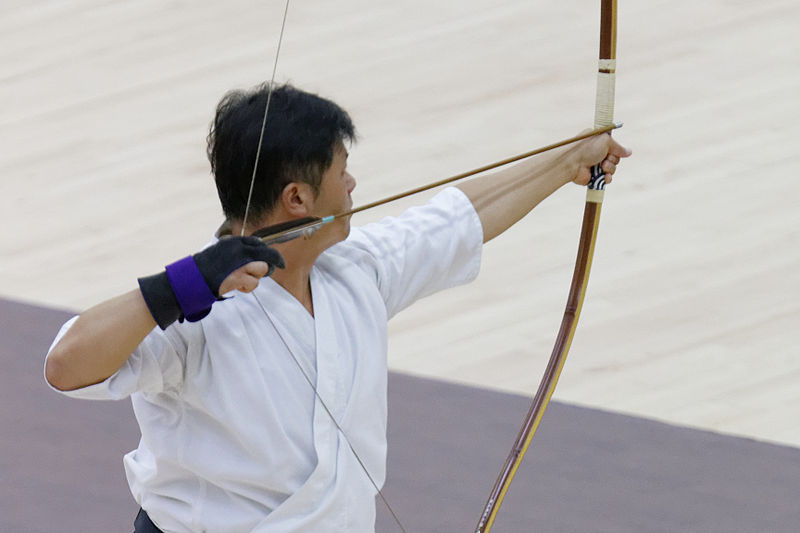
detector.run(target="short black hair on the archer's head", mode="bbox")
[207,83,356,220]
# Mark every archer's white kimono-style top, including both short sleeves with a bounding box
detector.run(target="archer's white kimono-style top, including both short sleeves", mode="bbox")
[47,189,483,533]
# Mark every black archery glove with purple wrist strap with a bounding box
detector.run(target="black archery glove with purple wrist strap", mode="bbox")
[139,237,286,329]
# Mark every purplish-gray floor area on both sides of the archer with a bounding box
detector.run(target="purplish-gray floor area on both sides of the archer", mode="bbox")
[6,299,800,533]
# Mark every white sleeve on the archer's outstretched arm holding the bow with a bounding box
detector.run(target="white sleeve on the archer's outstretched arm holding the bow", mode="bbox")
[346,188,483,317]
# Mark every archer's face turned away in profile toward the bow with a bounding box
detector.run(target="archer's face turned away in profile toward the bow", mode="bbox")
[311,144,356,242]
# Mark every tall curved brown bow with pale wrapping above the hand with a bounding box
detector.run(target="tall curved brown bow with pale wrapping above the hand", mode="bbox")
[476,0,617,533]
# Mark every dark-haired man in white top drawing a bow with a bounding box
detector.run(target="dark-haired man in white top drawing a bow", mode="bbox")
[45,81,630,533]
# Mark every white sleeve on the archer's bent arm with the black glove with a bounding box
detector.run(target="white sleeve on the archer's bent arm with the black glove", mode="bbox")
[45,317,187,400]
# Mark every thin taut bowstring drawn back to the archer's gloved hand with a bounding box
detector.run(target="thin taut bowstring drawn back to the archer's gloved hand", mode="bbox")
[240,0,407,533]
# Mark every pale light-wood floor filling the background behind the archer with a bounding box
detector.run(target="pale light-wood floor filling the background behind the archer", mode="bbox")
[0,0,800,446]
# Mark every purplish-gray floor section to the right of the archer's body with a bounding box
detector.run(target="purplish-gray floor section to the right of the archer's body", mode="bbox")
[378,374,800,533]
